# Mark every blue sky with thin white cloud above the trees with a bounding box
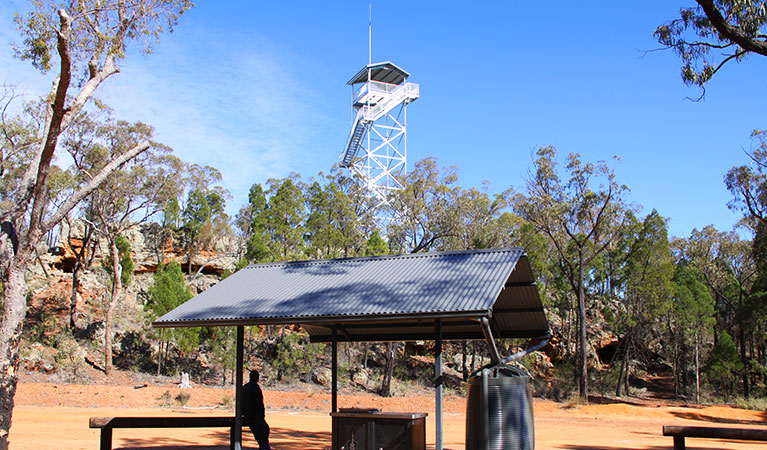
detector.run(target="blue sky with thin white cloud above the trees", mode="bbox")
[0,0,767,237]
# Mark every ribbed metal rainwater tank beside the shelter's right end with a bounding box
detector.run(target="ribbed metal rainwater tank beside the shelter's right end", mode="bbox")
[466,364,535,450]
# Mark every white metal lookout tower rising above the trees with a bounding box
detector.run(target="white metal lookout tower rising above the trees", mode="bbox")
[340,61,418,206]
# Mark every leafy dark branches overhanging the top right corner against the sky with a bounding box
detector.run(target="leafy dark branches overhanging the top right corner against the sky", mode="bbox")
[654,0,767,93]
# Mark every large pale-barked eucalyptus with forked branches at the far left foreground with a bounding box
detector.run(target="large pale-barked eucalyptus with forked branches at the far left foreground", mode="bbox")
[0,0,191,450]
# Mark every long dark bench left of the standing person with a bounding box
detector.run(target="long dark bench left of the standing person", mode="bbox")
[90,416,234,450]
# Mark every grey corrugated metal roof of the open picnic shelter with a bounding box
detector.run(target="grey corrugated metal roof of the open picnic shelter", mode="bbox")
[153,248,549,342]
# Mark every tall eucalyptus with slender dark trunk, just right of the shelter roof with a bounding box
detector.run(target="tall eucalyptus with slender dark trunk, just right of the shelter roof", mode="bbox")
[514,147,628,401]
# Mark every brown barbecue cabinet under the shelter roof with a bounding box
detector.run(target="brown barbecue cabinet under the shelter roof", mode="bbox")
[330,408,426,450]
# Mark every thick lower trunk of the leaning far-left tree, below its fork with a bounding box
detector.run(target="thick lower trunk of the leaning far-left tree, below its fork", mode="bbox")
[0,268,27,450]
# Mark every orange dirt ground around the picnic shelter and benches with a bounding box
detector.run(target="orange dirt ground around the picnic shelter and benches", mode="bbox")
[6,382,767,450]
